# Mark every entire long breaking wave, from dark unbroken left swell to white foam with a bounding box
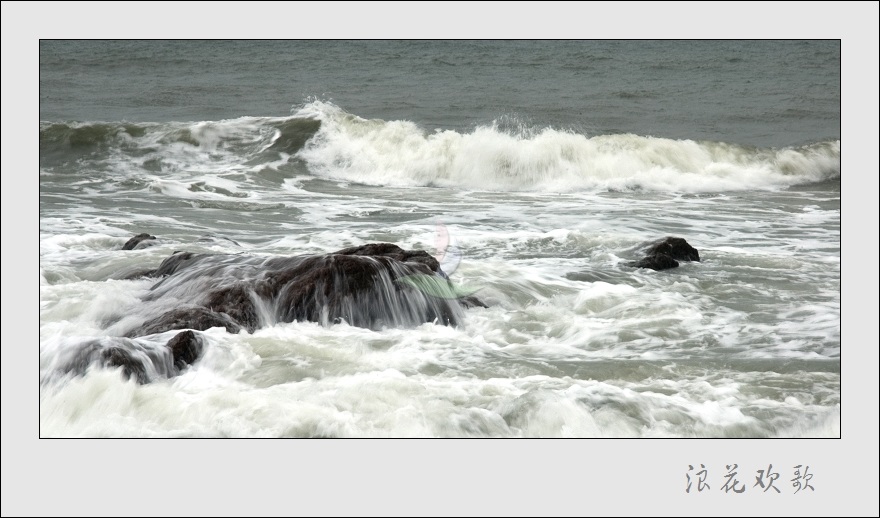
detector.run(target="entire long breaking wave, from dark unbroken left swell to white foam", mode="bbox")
[40,100,840,193]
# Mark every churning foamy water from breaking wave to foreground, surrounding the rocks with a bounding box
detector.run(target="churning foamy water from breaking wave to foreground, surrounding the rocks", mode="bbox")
[39,103,841,437]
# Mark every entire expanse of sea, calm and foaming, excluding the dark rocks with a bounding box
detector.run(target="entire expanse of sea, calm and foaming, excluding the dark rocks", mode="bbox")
[38,40,841,438]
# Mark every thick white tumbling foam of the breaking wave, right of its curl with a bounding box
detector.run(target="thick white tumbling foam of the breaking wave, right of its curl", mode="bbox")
[295,101,840,192]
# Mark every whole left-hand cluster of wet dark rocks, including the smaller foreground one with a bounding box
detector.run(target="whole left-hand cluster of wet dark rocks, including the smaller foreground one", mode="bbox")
[54,238,485,383]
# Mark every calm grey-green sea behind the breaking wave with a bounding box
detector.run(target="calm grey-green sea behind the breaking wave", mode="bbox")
[40,41,840,147]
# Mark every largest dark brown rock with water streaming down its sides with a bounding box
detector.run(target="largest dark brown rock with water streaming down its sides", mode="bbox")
[126,243,485,337]
